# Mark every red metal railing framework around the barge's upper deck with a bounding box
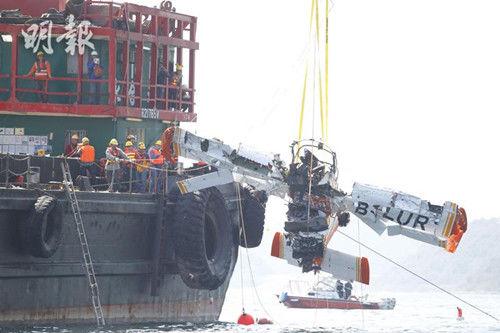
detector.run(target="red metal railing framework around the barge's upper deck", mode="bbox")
[0,0,199,121]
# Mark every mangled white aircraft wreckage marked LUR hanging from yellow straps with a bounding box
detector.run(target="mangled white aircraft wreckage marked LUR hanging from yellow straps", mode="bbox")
[162,127,467,284]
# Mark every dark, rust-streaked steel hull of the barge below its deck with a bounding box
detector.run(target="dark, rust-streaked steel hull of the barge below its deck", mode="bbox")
[0,188,238,326]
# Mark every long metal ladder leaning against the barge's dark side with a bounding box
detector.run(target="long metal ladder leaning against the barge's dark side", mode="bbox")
[61,160,106,327]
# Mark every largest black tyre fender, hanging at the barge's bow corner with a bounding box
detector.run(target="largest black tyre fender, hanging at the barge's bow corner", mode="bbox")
[173,188,235,290]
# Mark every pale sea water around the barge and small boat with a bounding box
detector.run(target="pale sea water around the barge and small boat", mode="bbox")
[0,289,500,333]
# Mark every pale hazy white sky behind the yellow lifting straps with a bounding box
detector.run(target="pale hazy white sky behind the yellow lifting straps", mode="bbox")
[142,0,500,219]
